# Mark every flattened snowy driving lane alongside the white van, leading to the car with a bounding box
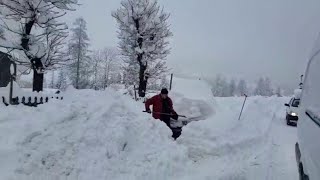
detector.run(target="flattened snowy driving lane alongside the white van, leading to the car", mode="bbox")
[247,102,298,180]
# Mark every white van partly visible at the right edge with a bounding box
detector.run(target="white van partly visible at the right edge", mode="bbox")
[295,39,320,180]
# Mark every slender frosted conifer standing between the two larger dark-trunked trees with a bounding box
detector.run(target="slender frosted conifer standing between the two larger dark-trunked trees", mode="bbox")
[69,18,92,89]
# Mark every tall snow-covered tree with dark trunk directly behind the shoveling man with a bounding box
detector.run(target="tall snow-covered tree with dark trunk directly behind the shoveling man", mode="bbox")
[112,0,172,97]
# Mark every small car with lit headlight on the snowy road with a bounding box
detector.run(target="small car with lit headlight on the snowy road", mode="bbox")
[284,97,300,125]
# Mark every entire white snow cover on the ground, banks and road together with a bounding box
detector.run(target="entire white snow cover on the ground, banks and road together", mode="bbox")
[0,78,298,180]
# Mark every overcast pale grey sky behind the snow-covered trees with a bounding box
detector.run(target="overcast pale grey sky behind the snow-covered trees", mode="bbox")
[66,0,320,87]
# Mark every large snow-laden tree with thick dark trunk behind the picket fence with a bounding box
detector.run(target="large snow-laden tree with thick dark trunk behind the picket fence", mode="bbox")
[0,0,77,91]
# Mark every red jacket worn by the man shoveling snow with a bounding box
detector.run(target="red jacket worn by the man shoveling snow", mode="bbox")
[145,94,177,119]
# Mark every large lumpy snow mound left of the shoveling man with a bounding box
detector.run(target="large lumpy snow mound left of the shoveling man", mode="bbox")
[0,90,191,180]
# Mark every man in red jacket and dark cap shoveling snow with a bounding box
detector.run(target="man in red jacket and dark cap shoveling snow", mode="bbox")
[145,88,184,139]
